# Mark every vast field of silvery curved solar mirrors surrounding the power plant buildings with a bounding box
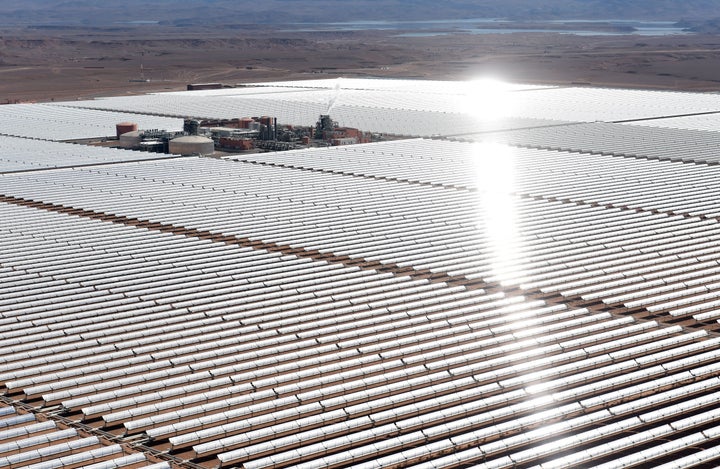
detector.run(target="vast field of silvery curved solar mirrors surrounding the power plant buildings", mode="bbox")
[0,79,720,469]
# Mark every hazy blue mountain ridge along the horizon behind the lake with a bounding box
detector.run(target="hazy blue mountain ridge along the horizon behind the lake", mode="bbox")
[0,0,720,28]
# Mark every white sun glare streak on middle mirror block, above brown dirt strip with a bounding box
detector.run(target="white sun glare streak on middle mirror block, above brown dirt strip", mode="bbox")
[471,143,523,285]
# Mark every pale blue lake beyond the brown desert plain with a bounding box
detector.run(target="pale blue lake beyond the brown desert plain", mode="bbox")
[289,18,692,37]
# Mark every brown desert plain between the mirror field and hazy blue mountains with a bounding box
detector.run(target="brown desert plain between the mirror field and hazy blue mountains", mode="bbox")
[0,25,720,103]
